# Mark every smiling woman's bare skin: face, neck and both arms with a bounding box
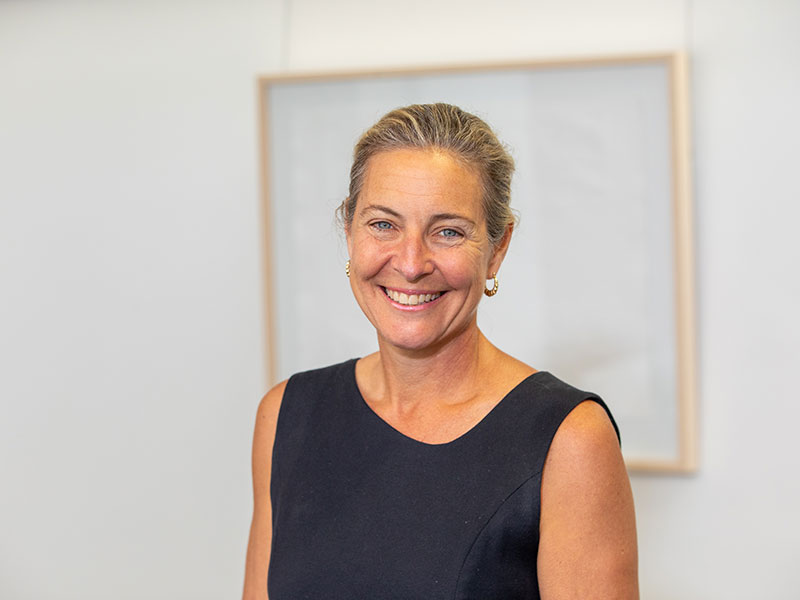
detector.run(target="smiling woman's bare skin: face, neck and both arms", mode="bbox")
[244,149,638,600]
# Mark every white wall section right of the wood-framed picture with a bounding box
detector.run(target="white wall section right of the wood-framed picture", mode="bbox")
[634,0,800,599]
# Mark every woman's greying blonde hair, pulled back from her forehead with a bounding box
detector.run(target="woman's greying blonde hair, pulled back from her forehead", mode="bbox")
[339,103,514,246]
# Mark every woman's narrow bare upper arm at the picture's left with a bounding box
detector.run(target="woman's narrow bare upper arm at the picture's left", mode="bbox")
[242,381,286,600]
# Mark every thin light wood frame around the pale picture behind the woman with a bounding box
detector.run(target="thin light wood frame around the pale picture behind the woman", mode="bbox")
[257,53,697,473]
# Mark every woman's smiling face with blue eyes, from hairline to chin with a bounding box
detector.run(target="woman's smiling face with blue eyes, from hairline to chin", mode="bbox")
[347,149,510,350]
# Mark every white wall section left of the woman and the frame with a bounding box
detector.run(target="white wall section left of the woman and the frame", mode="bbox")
[0,0,280,600]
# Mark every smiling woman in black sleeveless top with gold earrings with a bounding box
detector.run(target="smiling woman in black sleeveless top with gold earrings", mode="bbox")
[244,104,638,600]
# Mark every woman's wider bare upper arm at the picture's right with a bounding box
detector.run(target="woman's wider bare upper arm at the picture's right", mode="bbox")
[538,401,639,600]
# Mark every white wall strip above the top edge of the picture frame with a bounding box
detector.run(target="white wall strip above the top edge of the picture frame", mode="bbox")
[285,0,685,70]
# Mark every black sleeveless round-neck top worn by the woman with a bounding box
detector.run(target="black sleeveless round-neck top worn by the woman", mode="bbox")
[269,359,616,600]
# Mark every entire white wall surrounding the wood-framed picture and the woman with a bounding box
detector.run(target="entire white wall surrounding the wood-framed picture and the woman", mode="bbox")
[0,0,800,600]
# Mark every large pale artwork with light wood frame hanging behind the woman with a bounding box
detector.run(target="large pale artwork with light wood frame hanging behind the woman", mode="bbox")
[258,54,696,472]
